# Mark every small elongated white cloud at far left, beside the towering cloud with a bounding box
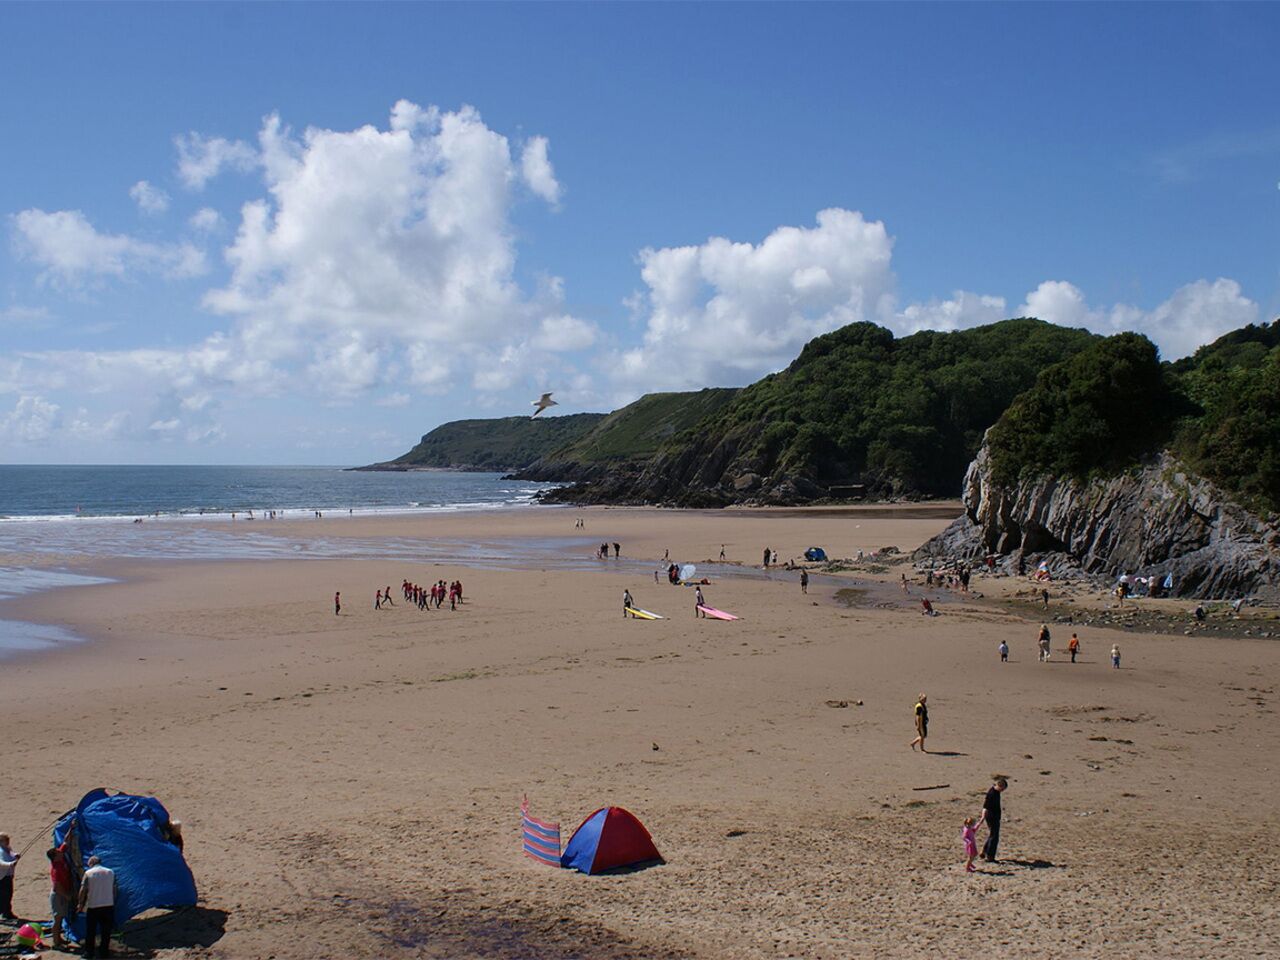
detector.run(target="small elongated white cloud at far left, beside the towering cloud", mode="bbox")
[13,209,206,287]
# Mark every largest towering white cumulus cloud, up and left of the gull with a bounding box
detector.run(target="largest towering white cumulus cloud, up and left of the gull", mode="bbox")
[205,101,583,398]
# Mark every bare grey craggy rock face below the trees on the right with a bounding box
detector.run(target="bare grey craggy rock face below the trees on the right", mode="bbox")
[916,447,1280,599]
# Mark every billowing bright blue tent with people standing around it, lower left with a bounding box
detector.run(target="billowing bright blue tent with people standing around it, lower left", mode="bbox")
[54,787,196,940]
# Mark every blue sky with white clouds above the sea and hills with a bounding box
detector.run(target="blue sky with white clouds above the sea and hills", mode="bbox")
[0,3,1280,465]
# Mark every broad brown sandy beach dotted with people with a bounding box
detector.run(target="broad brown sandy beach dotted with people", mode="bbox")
[0,507,1280,960]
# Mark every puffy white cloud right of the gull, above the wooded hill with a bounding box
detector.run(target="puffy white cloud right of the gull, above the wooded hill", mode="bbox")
[611,209,893,392]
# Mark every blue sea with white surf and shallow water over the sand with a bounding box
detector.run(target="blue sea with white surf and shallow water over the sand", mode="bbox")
[0,465,560,658]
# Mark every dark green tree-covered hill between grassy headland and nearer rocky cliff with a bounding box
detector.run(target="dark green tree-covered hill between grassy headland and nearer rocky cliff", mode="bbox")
[645,319,1097,497]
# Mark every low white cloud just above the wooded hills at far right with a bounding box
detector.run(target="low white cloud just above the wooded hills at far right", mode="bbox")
[1020,276,1260,360]
